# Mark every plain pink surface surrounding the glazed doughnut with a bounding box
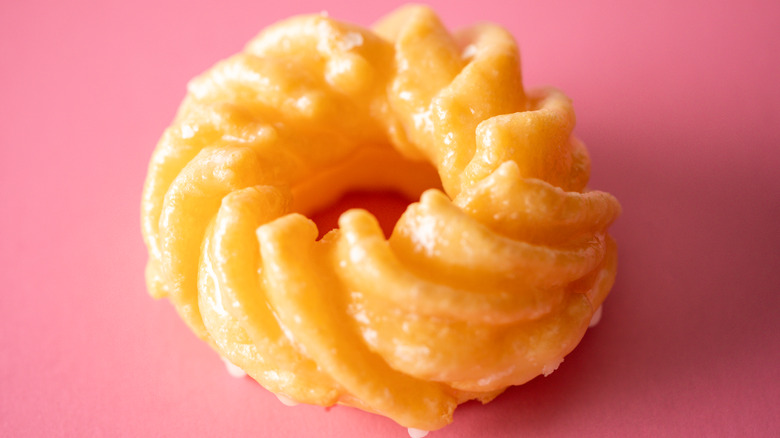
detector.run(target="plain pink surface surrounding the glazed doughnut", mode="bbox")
[0,0,780,438]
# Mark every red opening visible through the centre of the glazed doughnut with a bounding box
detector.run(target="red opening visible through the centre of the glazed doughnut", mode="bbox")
[310,190,417,240]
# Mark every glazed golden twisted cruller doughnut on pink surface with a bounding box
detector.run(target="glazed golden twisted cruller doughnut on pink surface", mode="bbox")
[142,6,620,436]
